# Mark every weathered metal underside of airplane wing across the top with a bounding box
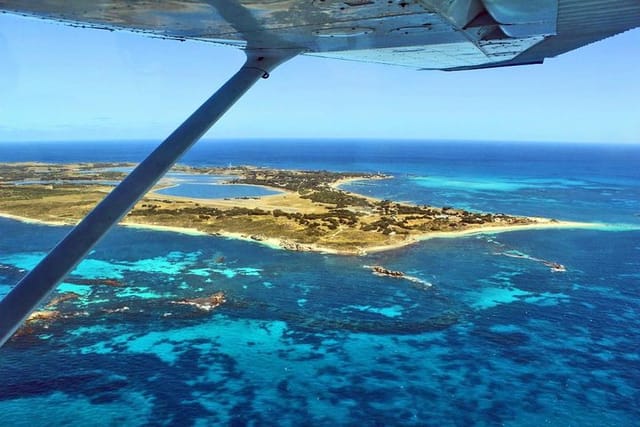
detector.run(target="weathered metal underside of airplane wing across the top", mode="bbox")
[0,0,640,70]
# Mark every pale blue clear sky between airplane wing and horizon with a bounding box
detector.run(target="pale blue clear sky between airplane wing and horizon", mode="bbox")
[0,14,640,143]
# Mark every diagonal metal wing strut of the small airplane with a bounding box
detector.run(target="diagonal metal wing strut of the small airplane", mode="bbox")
[0,51,298,346]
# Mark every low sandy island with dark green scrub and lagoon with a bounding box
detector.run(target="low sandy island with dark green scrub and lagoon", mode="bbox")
[0,163,583,255]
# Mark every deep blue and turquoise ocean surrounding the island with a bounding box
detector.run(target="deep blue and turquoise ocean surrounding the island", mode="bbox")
[0,140,640,427]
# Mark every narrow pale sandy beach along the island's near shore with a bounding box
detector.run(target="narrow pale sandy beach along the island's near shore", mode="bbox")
[0,212,615,256]
